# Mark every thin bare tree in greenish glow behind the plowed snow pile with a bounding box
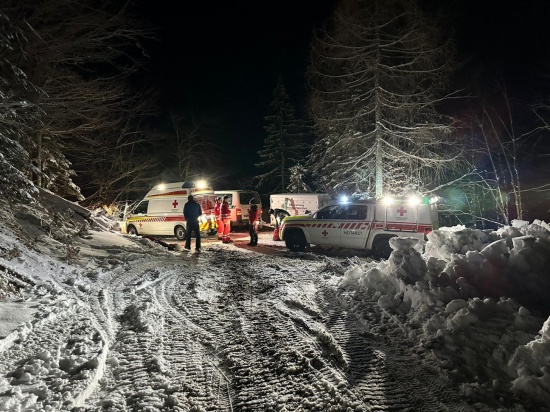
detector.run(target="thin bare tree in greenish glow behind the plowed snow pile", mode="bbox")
[441,86,541,227]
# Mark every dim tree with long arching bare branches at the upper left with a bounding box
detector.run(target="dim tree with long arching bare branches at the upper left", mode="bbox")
[3,0,157,201]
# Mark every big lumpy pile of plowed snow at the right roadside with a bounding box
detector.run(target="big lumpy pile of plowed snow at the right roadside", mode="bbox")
[343,220,550,403]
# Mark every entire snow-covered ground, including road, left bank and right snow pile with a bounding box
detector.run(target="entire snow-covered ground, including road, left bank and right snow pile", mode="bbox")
[0,194,550,411]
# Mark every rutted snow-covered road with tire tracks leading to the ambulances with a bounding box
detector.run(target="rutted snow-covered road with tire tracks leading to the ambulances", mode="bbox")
[0,237,470,411]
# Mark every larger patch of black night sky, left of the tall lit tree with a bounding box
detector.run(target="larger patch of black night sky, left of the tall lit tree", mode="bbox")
[140,0,336,176]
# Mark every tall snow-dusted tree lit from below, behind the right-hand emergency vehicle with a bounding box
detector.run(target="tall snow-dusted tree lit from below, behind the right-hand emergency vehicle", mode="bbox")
[308,0,460,197]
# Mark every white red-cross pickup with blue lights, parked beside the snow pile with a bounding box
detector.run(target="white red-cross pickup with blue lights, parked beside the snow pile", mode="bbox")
[280,196,439,259]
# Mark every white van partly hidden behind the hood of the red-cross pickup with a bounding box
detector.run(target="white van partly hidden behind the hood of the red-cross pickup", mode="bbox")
[269,193,331,225]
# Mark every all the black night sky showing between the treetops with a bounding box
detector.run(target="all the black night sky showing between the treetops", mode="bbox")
[139,0,550,179]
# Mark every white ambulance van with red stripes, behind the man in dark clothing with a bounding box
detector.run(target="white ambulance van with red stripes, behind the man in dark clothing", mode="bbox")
[122,182,216,240]
